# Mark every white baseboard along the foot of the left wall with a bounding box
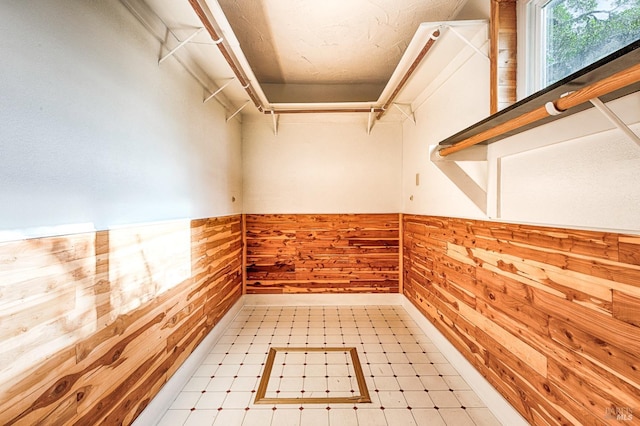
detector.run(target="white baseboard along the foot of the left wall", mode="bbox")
[133,298,244,426]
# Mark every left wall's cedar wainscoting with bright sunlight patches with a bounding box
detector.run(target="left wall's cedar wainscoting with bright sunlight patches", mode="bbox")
[0,216,242,425]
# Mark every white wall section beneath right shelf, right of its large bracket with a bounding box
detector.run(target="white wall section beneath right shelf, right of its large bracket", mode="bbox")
[489,93,640,233]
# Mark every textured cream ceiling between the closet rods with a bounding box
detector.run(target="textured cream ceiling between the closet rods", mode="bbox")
[219,0,466,95]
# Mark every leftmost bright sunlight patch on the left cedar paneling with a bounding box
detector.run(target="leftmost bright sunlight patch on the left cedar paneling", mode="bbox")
[0,232,97,386]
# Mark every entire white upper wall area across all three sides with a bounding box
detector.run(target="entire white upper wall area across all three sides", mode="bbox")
[5,0,640,239]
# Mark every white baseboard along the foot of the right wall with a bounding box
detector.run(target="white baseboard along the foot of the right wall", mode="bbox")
[402,296,529,426]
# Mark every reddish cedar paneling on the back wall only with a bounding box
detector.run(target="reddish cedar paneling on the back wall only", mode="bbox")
[246,214,400,293]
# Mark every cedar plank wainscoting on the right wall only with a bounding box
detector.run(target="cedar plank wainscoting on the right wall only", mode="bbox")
[403,215,640,425]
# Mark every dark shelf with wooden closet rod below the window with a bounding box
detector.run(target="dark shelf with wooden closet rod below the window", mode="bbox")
[439,40,640,147]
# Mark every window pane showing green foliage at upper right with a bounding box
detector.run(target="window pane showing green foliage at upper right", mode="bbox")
[543,0,640,86]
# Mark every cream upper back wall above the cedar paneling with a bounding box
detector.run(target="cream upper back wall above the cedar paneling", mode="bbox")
[242,114,402,213]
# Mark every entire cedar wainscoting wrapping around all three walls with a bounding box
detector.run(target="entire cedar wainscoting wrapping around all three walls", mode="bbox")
[0,214,640,424]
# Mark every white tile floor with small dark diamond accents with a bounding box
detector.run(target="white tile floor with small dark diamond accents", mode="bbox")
[159,306,500,426]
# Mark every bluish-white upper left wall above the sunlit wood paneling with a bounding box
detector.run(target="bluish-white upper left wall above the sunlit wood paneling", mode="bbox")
[0,0,242,240]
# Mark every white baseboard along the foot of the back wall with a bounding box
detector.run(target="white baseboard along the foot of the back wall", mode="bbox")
[244,293,405,306]
